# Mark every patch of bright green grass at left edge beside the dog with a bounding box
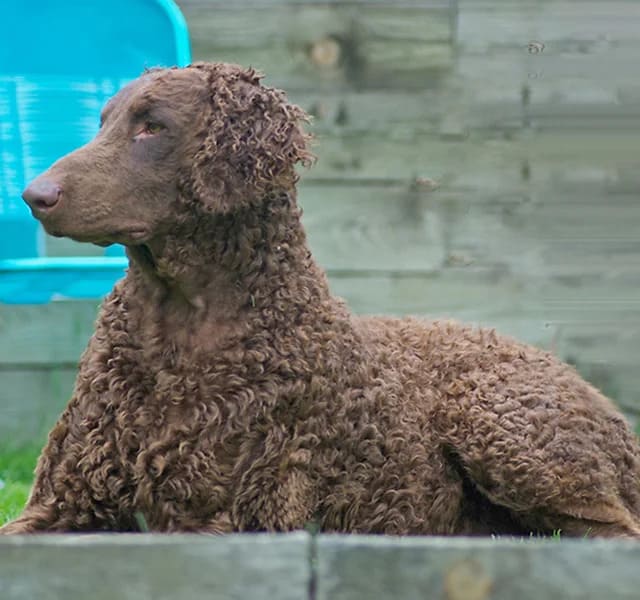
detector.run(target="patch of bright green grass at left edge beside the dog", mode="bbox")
[0,446,41,525]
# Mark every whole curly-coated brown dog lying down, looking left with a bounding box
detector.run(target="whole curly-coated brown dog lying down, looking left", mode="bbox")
[7,64,640,537]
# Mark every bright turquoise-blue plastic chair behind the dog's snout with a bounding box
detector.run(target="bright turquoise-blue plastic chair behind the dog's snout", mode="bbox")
[0,0,191,304]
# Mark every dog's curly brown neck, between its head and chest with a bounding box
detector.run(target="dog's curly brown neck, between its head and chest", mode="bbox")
[128,193,330,322]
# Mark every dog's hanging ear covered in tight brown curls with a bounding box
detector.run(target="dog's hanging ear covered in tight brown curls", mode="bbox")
[192,64,313,213]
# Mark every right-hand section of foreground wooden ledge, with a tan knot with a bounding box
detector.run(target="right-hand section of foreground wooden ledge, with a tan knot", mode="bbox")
[316,536,640,600]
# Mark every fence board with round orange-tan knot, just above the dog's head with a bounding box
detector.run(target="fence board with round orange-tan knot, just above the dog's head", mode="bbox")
[180,0,454,89]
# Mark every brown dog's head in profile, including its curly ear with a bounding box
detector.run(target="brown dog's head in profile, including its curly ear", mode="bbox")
[23,63,312,245]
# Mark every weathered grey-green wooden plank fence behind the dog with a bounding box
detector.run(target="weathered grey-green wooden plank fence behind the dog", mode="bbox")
[0,0,640,437]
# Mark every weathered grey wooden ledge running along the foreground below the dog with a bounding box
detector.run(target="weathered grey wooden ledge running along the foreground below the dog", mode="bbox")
[0,532,640,600]
